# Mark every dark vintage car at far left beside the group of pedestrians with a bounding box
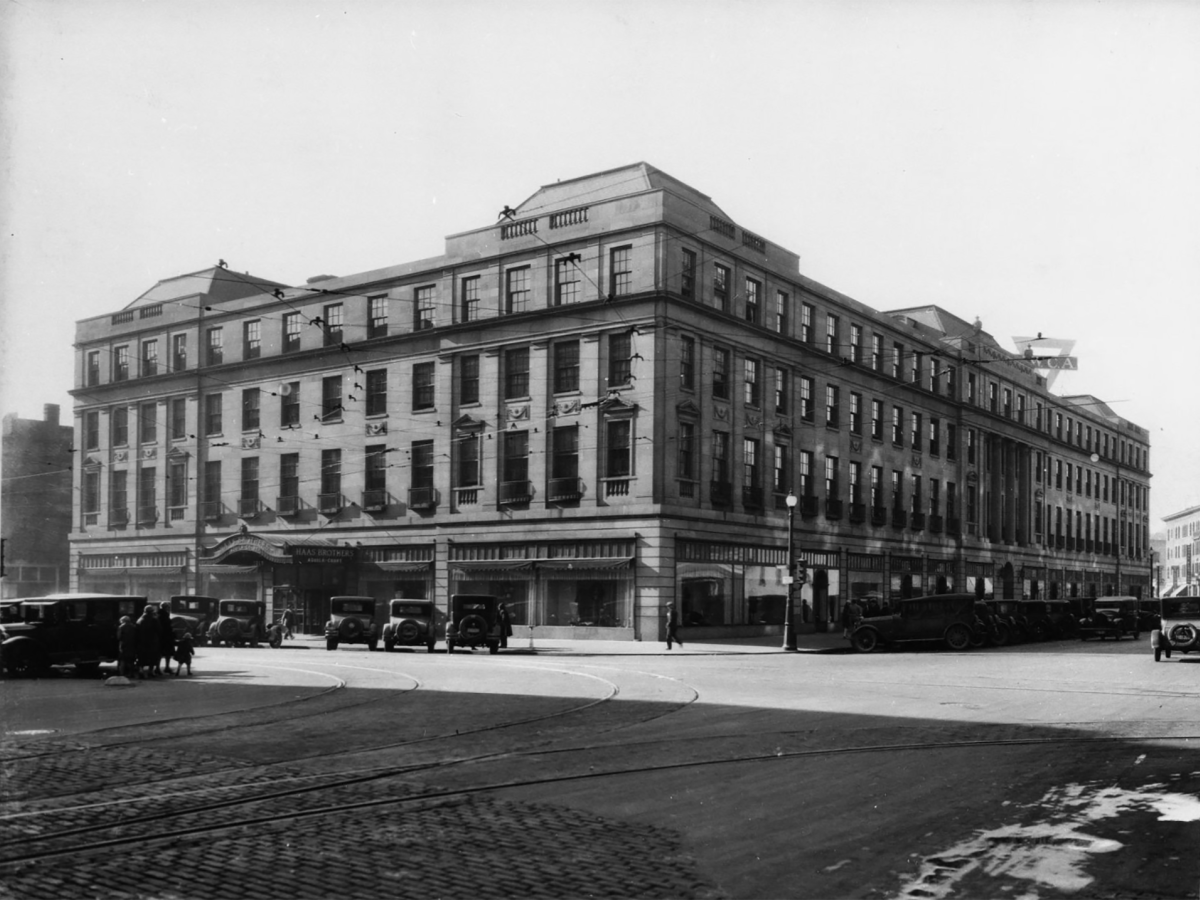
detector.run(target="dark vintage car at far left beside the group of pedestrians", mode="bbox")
[0,594,146,676]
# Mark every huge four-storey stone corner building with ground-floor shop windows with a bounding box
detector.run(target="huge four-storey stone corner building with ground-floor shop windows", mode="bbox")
[72,163,1150,640]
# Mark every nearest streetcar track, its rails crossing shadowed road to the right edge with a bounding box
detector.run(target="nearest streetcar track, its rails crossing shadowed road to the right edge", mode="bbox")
[0,733,1200,868]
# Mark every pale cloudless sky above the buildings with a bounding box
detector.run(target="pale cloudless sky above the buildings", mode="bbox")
[0,0,1200,530]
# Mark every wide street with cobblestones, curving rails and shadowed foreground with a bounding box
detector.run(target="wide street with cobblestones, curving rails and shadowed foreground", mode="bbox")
[0,637,1200,900]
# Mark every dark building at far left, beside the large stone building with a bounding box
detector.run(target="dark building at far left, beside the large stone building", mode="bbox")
[0,403,73,599]
